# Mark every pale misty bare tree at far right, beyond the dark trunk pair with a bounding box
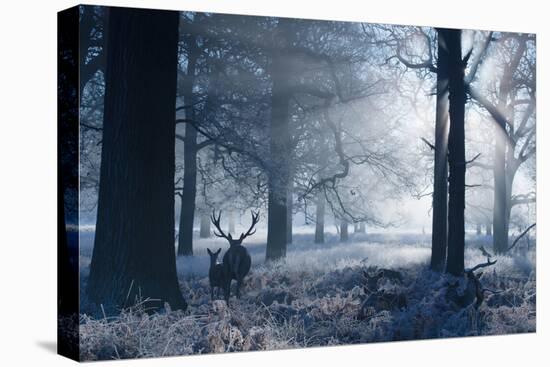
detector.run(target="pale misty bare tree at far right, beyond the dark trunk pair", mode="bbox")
[468,33,536,253]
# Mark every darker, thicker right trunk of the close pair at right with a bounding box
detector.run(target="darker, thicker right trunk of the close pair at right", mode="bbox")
[439,29,466,275]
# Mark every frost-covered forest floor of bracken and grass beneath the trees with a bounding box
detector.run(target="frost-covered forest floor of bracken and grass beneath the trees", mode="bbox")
[75,231,536,360]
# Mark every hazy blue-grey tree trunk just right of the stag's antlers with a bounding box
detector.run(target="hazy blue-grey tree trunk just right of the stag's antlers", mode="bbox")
[266,18,291,261]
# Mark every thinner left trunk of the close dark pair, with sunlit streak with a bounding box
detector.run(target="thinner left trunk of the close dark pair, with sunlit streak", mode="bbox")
[430,31,449,271]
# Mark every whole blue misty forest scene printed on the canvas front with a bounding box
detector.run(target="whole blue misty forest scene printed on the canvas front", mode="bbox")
[58,6,537,360]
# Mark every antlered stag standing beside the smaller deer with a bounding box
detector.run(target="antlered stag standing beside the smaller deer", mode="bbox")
[211,211,260,302]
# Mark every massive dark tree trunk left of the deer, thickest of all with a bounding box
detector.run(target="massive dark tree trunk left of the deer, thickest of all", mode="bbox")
[87,8,187,311]
